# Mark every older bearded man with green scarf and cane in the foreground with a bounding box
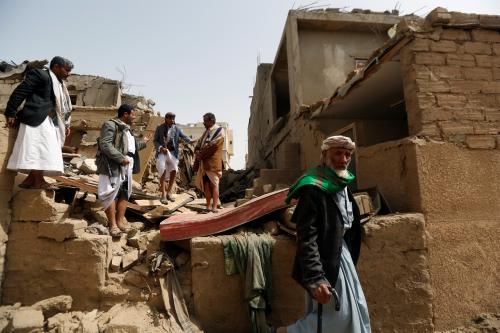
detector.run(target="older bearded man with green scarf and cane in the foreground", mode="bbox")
[277,135,371,333]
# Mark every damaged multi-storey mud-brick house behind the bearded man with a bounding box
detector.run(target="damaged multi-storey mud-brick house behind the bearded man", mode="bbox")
[248,8,500,332]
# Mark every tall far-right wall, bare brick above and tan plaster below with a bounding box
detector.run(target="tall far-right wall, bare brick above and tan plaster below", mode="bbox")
[401,15,500,330]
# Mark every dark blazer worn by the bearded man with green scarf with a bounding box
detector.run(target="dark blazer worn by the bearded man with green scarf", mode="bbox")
[292,185,361,293]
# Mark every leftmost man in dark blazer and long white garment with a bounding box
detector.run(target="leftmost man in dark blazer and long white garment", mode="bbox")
[5,57,73,190]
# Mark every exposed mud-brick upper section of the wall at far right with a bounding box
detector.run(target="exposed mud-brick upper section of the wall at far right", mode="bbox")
[401,27,500,149]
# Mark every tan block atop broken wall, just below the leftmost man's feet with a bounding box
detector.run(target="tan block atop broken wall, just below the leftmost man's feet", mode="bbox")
[12,190,69,221]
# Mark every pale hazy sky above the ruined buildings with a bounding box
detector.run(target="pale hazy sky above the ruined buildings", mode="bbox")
[0,0,500,169]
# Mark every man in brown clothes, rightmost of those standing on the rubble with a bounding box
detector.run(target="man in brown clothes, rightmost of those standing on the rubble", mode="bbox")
[195,112,224,213]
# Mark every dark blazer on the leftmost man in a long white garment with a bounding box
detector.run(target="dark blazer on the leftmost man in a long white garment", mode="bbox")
[5,69,55,126]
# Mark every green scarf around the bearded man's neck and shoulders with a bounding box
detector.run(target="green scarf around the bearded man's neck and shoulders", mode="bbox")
[285,165,356,204]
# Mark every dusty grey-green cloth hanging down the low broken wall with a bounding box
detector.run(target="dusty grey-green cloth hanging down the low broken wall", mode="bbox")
[222,233,275,333]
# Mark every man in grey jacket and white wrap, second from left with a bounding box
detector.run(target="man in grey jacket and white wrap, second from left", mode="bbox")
[96,104,149,237]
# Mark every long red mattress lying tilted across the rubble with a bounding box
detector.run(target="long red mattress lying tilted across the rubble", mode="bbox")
[160,189,289,241]
